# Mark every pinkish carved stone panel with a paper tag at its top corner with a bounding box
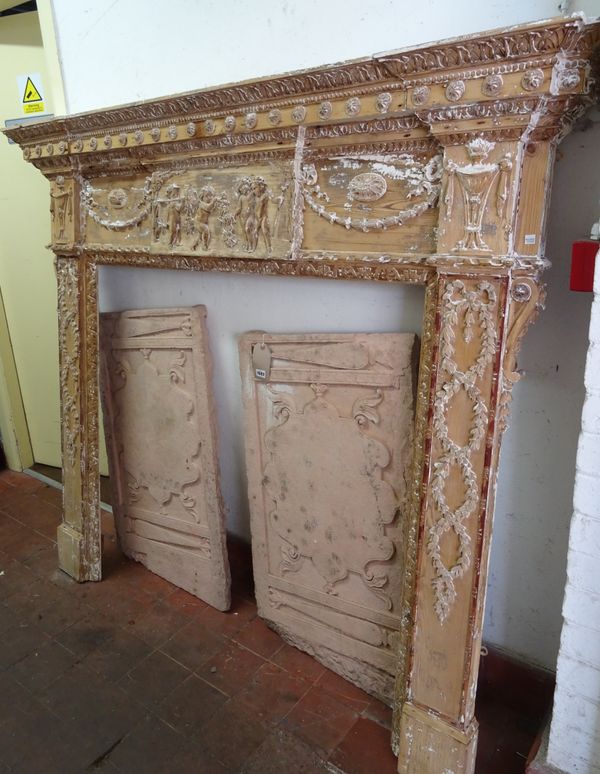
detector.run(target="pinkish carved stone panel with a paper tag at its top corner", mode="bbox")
[240,333,416,702]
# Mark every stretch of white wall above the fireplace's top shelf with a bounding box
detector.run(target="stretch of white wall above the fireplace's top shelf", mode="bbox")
[51,0,600,113]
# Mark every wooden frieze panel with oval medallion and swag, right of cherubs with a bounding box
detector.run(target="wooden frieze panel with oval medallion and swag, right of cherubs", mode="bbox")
[301,153,442,254]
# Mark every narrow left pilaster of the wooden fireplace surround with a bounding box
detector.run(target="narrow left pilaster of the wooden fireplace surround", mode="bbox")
[56,255,101,581]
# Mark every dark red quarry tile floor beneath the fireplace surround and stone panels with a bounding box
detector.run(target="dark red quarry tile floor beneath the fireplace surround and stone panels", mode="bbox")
[0,472,551,774]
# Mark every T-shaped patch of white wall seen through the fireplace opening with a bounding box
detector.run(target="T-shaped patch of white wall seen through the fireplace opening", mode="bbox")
[100,266,424,539]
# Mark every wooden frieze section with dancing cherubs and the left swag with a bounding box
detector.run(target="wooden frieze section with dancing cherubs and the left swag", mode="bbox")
[82,162,294,258]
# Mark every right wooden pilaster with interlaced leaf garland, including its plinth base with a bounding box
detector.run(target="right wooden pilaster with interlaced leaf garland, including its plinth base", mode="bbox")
[397,270,509,774]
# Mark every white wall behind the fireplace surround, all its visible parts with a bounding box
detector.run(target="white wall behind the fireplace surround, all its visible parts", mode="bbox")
[52,0,600,668]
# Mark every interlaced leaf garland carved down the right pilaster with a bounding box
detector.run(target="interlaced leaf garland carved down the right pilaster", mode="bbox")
[427,280,498,623]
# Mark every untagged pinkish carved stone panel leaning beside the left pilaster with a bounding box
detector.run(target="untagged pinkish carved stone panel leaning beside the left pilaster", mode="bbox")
[101,306,230,610]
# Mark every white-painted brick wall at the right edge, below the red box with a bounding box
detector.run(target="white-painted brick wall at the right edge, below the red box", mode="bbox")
[547,253,600,774]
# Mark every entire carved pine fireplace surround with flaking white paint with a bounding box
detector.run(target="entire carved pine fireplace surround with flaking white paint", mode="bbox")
[5,13,600,774]
